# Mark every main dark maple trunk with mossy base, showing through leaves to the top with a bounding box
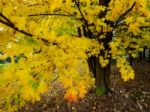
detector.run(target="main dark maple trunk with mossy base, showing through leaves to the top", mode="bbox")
[92,0,113,95]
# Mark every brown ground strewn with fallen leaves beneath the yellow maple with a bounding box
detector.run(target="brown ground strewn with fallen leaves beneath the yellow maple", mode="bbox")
[21,60,150,112]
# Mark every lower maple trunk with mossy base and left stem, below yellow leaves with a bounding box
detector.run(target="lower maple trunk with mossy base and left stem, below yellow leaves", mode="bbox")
[88,53,111,95]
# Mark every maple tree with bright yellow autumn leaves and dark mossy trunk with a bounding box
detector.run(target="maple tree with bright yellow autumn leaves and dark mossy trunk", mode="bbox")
[0,0,150,111]
